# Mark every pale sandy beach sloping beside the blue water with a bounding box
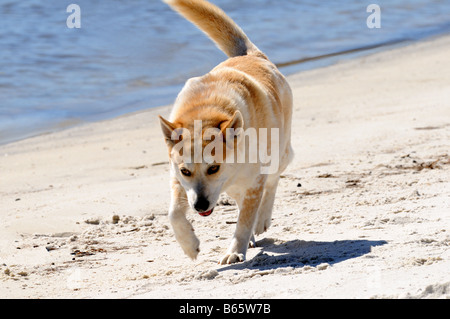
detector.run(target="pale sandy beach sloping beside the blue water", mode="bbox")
[0,36,450,299]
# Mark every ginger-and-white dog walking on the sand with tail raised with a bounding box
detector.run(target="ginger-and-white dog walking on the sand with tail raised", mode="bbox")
[159,0,293,265]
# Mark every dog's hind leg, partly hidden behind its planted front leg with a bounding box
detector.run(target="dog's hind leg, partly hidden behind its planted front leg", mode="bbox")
[253,175,280,235]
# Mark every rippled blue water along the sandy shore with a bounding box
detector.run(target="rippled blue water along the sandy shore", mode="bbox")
[0,0,450,144]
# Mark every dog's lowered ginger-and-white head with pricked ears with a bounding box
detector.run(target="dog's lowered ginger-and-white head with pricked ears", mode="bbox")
[160,111,244,216]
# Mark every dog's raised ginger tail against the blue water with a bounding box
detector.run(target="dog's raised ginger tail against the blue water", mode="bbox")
[163,0,265,57]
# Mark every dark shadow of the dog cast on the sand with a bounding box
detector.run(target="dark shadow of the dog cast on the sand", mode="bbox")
[218,238,387,272]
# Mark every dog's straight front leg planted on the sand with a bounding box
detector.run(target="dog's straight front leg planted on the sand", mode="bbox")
[219,175,267,265]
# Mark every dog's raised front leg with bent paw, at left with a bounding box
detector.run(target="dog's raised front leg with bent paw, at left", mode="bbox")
[169,177,200,259]
